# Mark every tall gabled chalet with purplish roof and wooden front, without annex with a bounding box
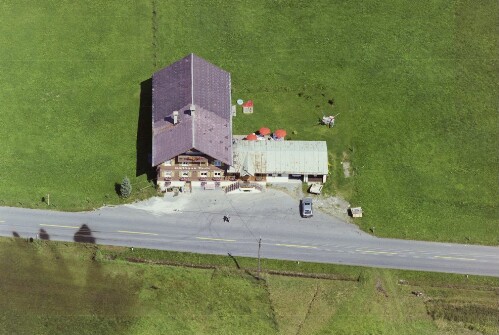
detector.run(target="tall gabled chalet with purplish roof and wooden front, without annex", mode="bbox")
[152,54,232,192]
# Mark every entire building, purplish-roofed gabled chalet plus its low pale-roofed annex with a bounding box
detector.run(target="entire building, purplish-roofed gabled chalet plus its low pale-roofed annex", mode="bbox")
[152,54,328,191]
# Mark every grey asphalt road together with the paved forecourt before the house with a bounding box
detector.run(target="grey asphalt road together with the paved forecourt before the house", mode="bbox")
[0,190,499,277]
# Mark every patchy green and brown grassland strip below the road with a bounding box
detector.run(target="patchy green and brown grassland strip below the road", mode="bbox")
[0,238,499,335]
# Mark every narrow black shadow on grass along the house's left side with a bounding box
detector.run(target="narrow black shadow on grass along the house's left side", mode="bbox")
[135,78,156,180]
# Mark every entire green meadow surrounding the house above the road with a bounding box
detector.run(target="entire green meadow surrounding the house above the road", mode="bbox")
[0,0,499,245]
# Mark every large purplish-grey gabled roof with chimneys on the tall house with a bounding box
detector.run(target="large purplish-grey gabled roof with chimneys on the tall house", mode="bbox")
[152,54,232,166]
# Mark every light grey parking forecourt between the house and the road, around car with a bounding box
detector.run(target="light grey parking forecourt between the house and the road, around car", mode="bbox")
[127,183,365,235]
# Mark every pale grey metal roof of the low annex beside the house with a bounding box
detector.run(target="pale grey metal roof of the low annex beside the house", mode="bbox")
[229,140,328,175]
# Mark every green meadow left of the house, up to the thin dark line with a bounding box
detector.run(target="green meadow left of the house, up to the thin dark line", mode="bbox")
[0,1,154,210]
